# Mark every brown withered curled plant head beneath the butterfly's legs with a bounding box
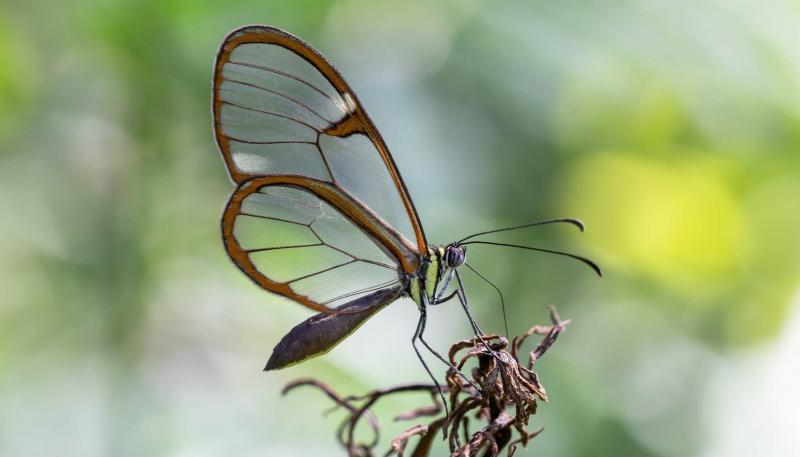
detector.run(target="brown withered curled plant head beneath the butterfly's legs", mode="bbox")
[283,306,570,457]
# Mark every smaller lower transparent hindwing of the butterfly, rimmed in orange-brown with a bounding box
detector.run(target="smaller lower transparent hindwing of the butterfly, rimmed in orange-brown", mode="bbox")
[222,176,412,312]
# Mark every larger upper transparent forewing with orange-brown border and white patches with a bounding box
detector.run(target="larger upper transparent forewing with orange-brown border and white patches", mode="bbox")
[213,26,427,256]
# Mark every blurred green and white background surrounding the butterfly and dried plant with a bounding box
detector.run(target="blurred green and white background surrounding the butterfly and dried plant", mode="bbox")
[0,0,800,457]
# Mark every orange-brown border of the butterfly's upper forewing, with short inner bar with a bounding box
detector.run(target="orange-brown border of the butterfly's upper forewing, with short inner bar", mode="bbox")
[212,25,428,255]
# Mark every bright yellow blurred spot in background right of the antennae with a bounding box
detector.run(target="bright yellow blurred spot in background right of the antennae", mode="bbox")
[563,152,744,294]
